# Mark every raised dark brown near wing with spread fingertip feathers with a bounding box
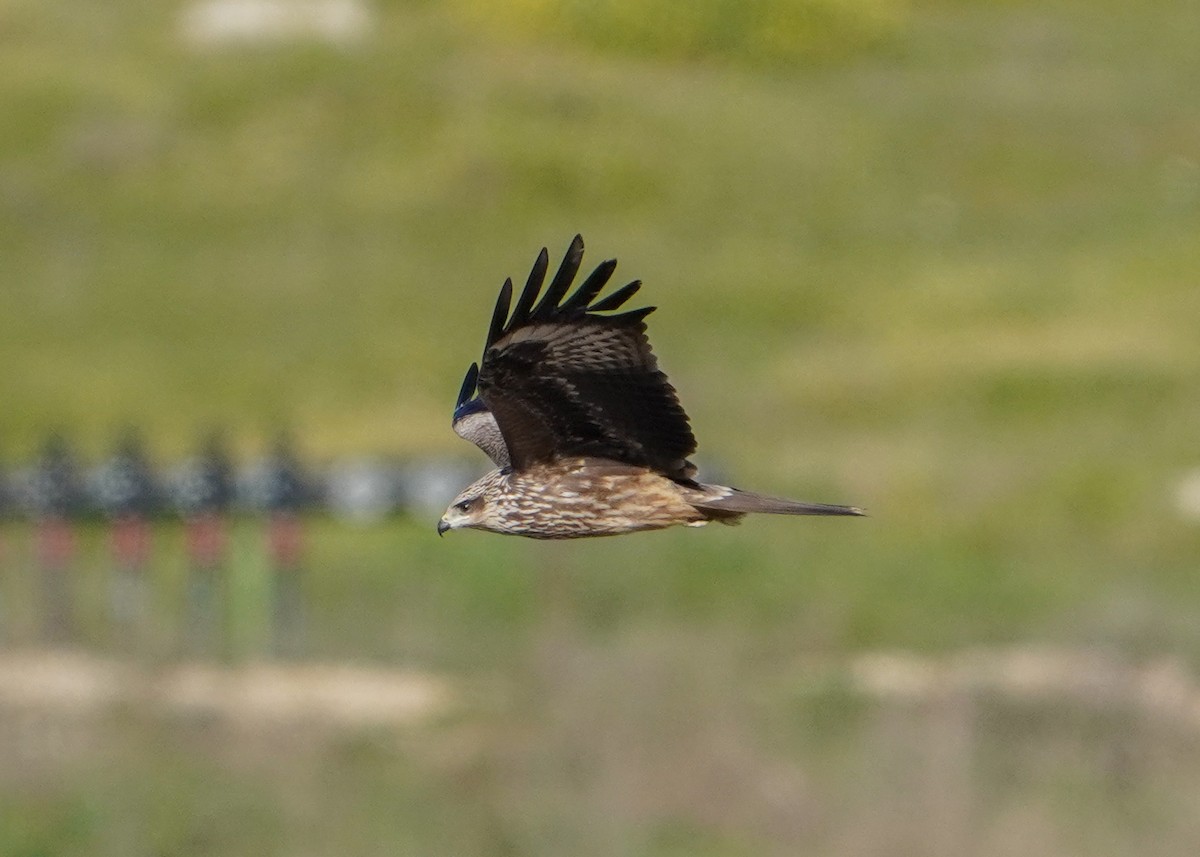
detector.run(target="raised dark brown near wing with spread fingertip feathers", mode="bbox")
[468,235,696,475]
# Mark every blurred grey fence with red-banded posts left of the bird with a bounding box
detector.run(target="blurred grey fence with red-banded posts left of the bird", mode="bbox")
[0,431,473,658]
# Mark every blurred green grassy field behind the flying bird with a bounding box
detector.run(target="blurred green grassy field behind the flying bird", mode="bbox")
[0,0,1200,857]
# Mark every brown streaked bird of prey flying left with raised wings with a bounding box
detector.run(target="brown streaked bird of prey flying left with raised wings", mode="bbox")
[438,235,863,539]
